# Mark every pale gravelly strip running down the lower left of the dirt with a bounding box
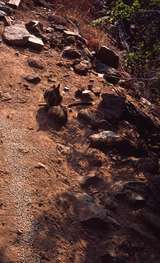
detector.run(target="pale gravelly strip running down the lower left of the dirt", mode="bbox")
[0,113,40,263]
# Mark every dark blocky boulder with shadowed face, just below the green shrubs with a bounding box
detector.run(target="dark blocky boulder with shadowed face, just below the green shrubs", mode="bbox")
[97,46,119,68]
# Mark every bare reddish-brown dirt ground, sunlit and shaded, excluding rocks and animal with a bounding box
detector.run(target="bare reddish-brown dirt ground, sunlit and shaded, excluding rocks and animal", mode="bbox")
[0,2,160,263]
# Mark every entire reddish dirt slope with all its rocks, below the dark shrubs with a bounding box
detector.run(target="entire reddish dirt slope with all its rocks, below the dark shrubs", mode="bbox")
[0,0,160,263]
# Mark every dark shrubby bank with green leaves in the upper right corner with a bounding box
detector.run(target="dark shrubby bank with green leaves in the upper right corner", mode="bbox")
[92,0,160,105]
